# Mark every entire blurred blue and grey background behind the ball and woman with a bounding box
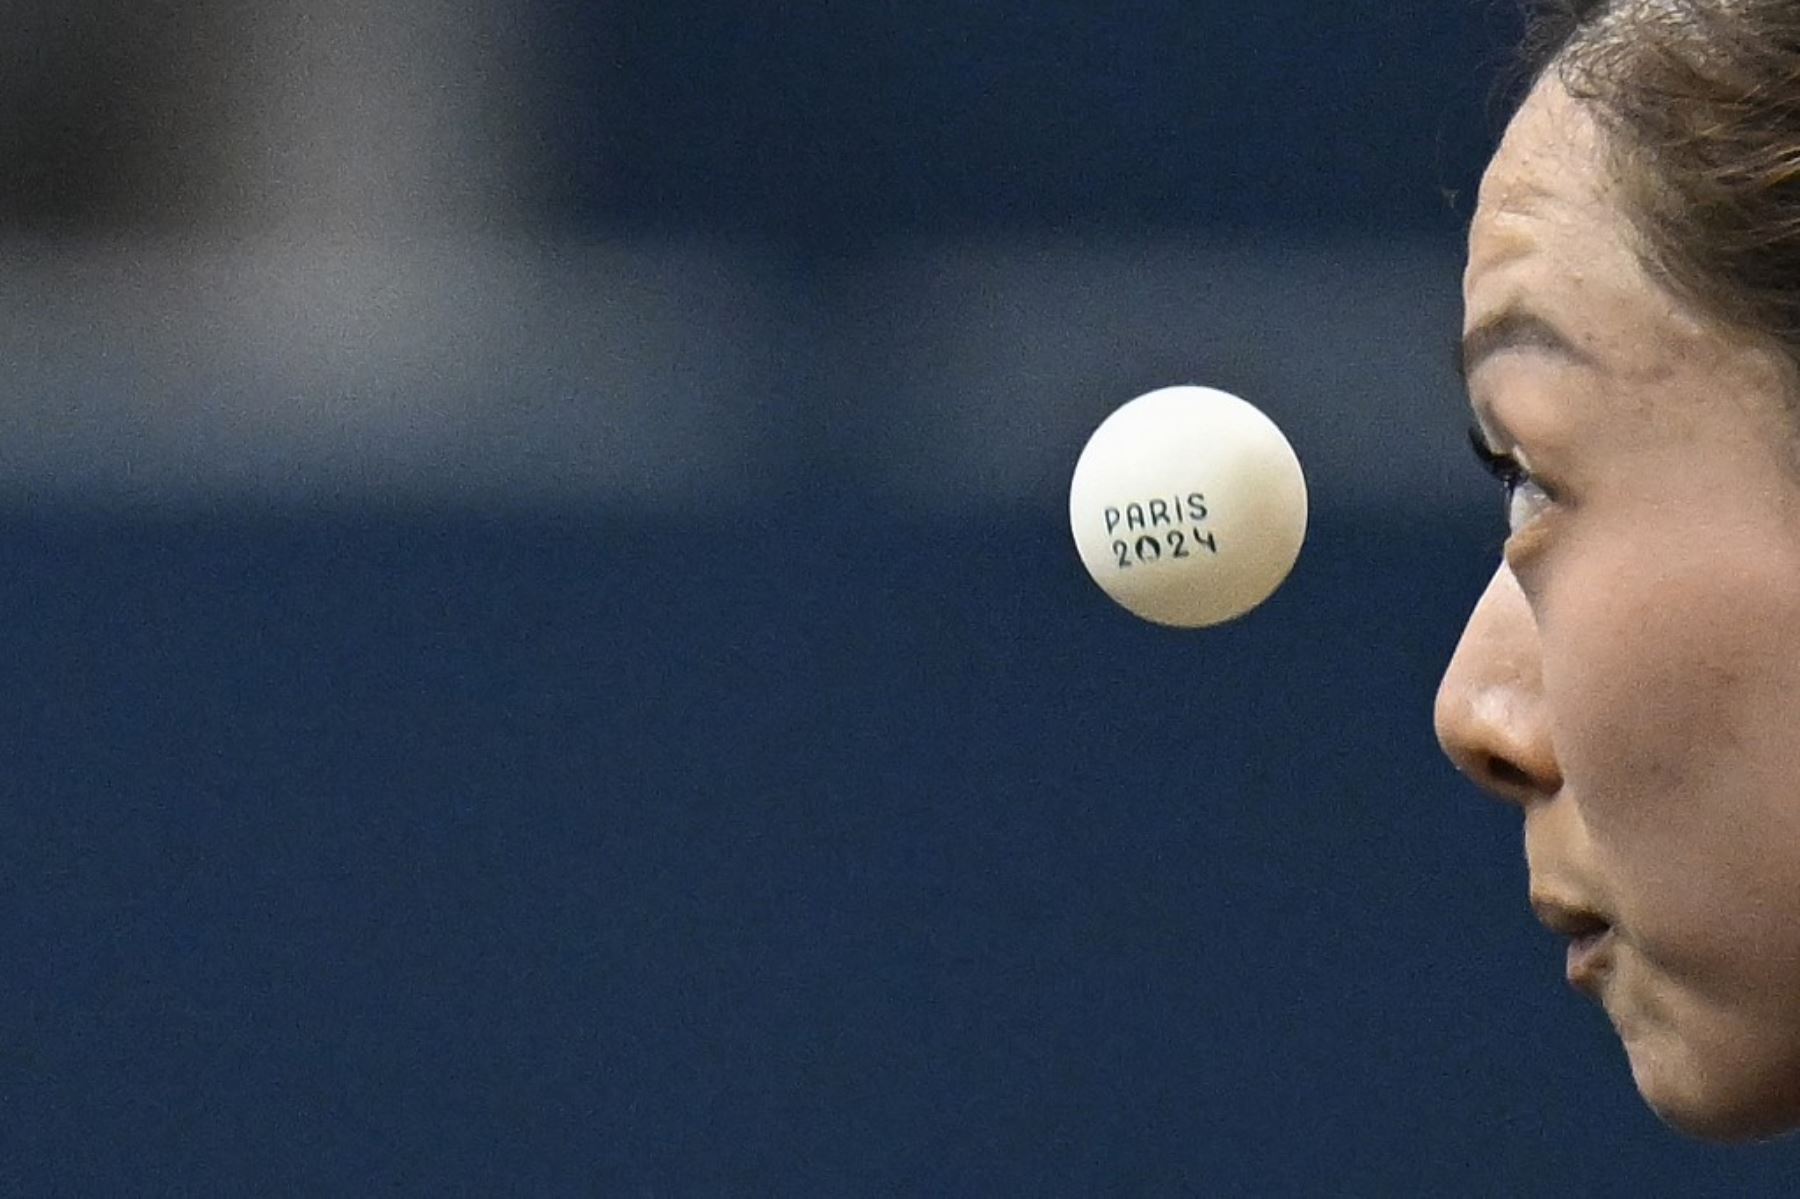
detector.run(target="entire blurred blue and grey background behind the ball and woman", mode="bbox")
[0,0,1800,1195]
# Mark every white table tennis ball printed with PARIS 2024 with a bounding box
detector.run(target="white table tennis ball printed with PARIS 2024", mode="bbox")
[1069,387,1307,628]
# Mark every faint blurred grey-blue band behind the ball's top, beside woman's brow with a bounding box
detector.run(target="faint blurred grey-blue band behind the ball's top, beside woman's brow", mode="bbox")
[826,238,1487,509]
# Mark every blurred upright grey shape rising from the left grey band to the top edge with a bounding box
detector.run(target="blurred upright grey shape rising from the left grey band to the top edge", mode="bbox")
[220,0,538,228]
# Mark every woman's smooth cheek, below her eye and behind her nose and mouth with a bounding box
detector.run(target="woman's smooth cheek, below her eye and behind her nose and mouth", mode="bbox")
[1541,531,1800,979]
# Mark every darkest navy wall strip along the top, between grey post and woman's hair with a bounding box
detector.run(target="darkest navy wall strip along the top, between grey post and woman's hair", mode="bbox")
[540,0,1519,243]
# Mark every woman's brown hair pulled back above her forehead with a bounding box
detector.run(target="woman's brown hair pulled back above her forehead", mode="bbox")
[1526,0,1800,354]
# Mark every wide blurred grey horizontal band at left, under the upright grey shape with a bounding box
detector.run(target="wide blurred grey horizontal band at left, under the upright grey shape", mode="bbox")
[0,234,795,509]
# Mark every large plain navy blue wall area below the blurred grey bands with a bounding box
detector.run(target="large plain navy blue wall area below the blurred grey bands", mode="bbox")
[14,495,1800,1195]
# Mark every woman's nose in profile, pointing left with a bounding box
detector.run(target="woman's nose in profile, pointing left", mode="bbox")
[1433,563,1562,807]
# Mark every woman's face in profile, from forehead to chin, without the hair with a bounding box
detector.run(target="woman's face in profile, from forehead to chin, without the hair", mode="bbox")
[1436,83,1800,1140]
